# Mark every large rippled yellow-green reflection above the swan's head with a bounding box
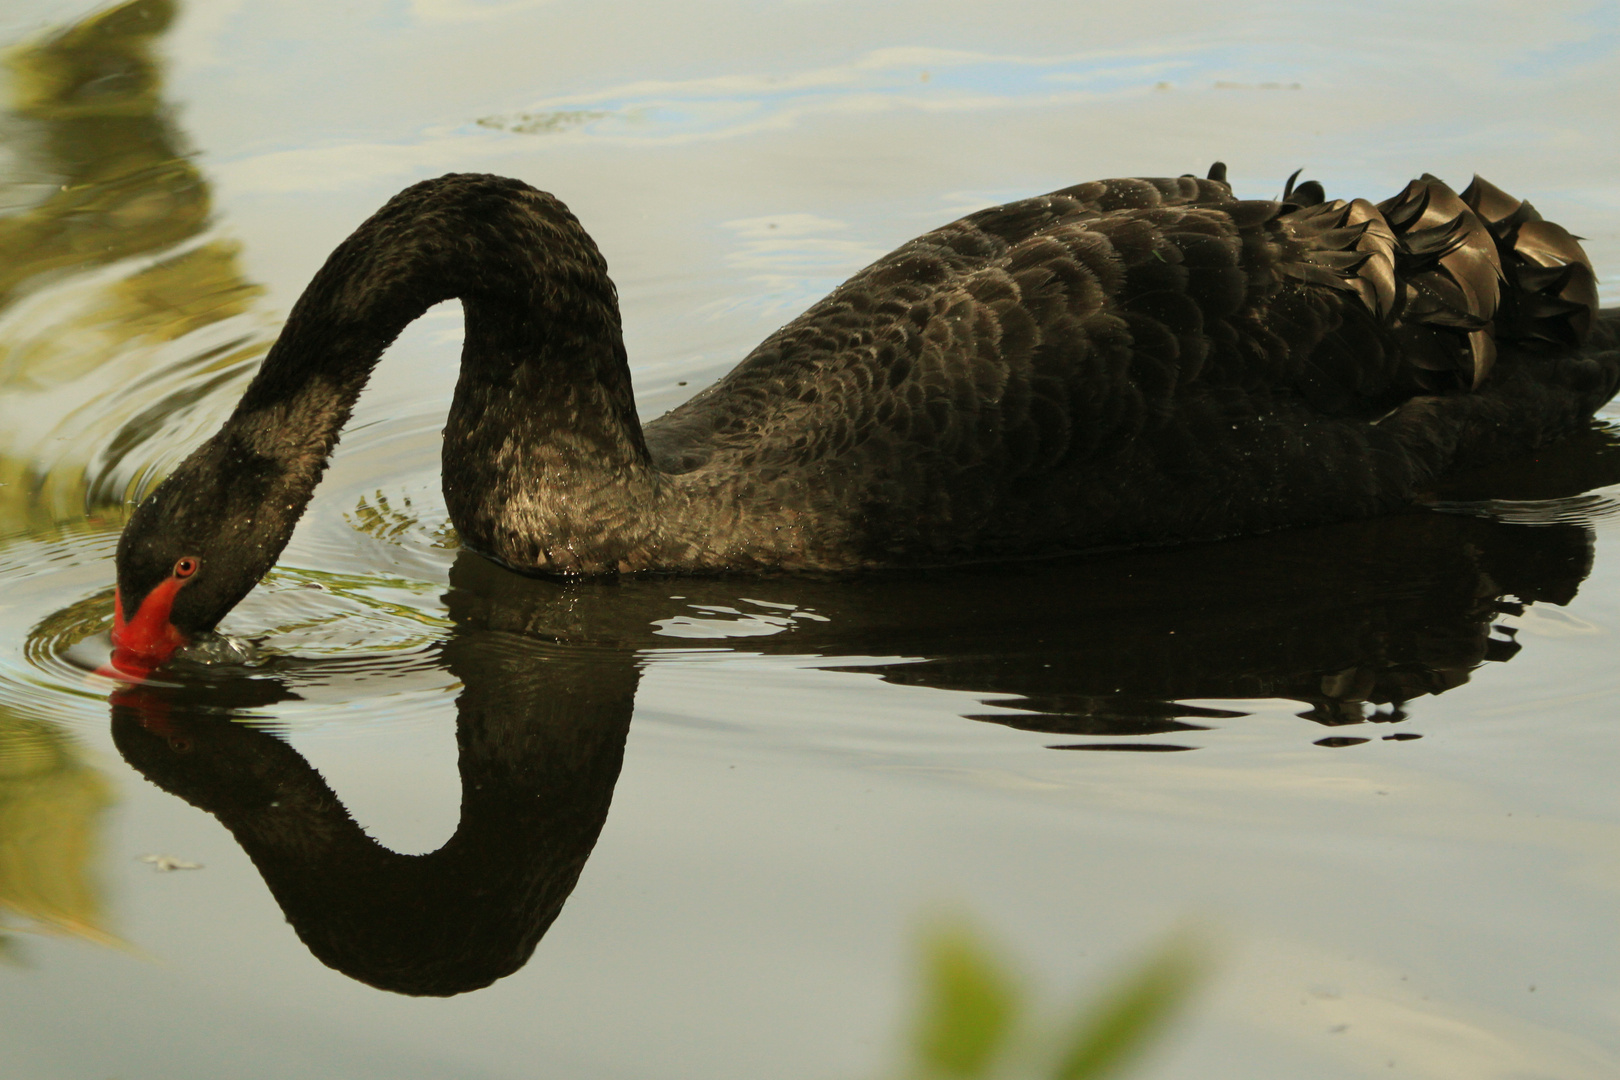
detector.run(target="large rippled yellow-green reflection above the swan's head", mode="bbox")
[0,0,266,536]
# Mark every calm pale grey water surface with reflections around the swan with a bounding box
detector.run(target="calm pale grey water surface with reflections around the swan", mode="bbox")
[0,0,1620,1080]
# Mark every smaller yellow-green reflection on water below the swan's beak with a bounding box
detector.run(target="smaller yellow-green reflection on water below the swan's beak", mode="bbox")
[0,712,118,963]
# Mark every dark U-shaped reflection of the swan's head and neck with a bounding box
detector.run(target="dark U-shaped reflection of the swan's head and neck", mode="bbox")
[112,630,638,996]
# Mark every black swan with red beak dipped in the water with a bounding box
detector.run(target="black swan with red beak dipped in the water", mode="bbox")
[113,164,1620,674]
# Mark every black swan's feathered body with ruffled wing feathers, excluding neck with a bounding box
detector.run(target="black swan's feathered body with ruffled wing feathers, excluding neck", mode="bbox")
[628,165,1620,565]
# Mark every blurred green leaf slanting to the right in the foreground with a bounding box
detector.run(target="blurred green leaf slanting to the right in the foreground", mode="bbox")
[1051,933,1210,1080]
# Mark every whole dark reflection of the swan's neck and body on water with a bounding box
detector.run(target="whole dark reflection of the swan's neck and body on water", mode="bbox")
[112,469,1592,994]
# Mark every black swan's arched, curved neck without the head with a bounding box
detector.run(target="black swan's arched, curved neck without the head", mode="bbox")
[217,175,656,572]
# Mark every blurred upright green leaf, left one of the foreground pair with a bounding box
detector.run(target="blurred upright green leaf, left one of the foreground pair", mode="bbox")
[915,923,1021,1077]
